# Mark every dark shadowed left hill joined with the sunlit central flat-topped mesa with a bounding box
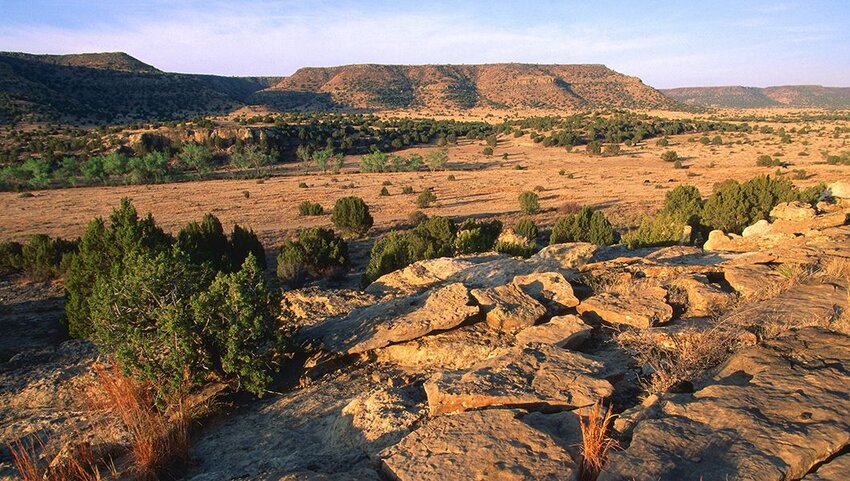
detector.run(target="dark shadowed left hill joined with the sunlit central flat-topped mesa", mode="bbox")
[0,52,676,123]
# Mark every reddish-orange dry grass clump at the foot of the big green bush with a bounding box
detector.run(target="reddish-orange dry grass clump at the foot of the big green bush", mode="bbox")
[89,366,189,479]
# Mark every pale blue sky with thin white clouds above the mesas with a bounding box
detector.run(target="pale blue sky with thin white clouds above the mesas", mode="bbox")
[0,0,850,88]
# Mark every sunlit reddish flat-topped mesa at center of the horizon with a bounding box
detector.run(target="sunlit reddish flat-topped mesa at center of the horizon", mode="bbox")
[269,64,673,109]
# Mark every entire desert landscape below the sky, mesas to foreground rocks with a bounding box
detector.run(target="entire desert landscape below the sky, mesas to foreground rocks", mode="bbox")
[0,31,850,481]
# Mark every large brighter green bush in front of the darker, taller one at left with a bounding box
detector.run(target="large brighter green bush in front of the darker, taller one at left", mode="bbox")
[90,249,281,397]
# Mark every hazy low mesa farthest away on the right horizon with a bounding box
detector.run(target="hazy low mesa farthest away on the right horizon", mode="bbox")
[661,85,850,109]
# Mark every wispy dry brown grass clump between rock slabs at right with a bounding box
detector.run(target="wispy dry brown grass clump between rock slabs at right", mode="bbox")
[617,322,741,393]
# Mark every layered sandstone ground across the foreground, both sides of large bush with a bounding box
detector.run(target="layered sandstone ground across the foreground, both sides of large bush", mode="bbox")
[0,189,850,481]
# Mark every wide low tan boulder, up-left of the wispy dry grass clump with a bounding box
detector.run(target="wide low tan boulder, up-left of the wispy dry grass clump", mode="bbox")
[577,283,673,328]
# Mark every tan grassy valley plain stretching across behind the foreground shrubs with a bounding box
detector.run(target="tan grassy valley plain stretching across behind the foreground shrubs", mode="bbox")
[0,113,850,247]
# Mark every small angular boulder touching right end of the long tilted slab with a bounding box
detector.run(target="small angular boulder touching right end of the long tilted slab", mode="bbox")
[472,284,546,331]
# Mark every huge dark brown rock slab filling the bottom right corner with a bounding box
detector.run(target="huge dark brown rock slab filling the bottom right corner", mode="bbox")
[598,328,850,481]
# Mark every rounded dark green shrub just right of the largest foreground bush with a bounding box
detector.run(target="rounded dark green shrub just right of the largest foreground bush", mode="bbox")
[277,227,348,287]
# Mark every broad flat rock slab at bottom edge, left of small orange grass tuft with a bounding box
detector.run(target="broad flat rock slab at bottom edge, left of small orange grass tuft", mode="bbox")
[381,409,578,481]
